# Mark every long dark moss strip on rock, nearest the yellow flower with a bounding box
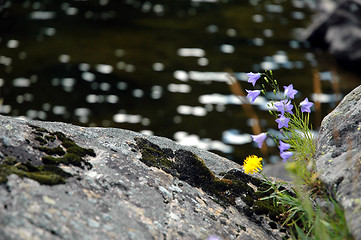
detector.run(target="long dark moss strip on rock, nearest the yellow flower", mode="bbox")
[135,138,282,224]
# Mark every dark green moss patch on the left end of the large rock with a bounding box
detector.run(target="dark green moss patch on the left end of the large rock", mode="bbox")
[0,125,95,185]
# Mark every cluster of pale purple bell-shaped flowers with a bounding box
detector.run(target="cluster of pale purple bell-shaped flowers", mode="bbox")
[246,72,313,161]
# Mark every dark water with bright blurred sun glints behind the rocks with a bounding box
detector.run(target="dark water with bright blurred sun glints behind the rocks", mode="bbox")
[0,0,358,165]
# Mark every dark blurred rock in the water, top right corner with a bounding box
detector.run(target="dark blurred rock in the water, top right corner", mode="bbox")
[304,0,361,71]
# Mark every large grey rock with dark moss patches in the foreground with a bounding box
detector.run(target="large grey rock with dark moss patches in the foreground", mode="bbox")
[0,116,286,240]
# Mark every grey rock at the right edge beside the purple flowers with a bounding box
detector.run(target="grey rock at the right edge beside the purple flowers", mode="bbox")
[315,86,361,239]
